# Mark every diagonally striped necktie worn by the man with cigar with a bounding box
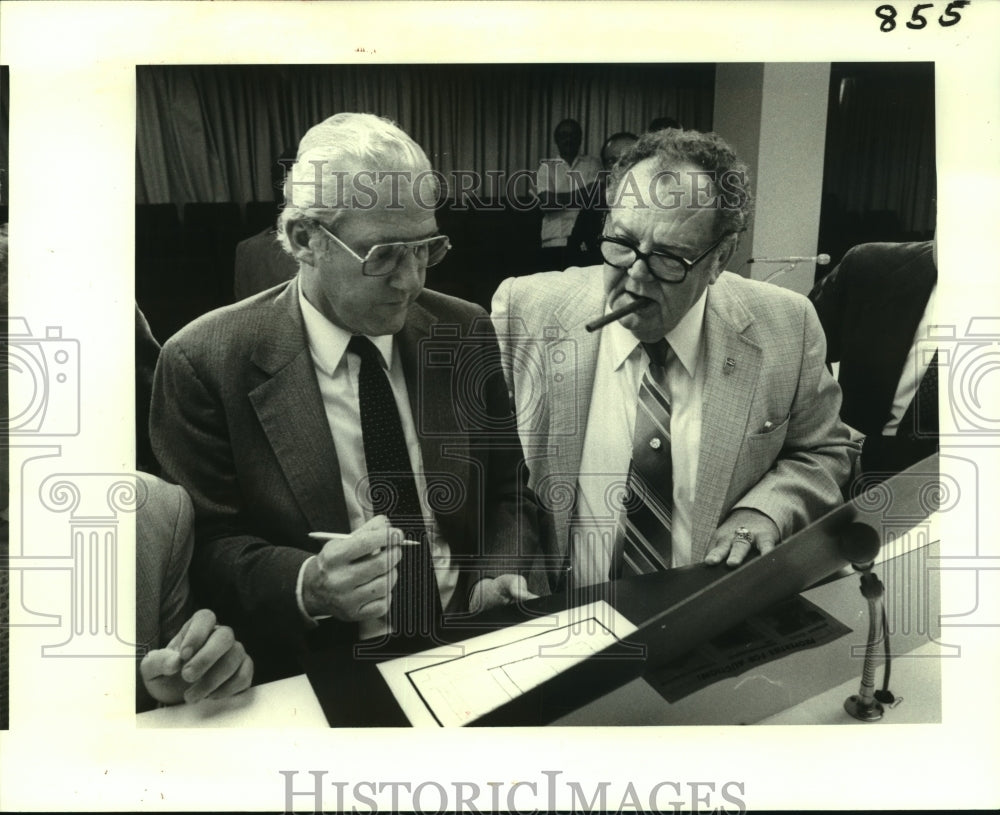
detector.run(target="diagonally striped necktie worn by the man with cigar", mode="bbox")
[611,340,674,579]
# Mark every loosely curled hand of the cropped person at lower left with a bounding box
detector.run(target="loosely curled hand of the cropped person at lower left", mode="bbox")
[139,608,253,705]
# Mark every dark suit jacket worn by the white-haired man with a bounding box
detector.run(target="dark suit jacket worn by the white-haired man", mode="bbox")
[150,280,536,681]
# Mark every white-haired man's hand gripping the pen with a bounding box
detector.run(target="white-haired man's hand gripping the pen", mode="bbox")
[302,515,405,622]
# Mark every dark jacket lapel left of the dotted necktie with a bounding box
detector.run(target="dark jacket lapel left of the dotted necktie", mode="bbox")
[249,283,349,532]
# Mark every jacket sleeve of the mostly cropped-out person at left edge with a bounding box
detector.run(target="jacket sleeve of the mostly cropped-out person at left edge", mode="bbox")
[135,473,194,711]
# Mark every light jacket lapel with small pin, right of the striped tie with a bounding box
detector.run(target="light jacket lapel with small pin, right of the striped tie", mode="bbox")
[691,283,763,560]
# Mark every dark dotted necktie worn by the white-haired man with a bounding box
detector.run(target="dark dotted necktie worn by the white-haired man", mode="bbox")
[347,335,441,637]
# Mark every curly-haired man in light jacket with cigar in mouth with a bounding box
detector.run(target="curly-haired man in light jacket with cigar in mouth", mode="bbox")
[493,130,858,589]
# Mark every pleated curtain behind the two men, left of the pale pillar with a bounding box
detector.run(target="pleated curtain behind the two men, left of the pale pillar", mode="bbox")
[136,64,715,206]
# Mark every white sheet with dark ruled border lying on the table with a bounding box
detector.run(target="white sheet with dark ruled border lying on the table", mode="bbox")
[378,600,636,727]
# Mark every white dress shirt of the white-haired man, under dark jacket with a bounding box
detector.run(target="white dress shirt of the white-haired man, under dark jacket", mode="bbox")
[295,281,458,639]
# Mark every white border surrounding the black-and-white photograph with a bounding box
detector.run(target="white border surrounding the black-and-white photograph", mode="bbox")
[0,0,1000,811]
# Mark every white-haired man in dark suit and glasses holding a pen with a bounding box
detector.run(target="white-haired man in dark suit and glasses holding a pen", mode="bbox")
[150,113,536,680]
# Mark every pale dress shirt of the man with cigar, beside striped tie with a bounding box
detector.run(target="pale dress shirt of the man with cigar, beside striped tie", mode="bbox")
[570,290,707,586]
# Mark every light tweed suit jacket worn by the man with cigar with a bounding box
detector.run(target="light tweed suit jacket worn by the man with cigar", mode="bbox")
[492,266,859,588]
